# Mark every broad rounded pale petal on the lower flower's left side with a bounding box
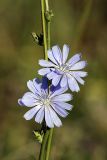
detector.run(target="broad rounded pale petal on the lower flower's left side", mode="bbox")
[22,92,38,107]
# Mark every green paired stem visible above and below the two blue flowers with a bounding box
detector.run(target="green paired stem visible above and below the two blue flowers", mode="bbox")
[39,0,53,160]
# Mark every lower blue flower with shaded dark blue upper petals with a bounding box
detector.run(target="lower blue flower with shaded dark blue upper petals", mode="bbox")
[18,77,72,128]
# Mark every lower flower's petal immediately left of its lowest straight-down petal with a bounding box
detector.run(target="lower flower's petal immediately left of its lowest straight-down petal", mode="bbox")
[35,106,45,123]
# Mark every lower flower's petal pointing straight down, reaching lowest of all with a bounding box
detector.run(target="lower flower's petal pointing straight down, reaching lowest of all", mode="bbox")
[45,106,54,128]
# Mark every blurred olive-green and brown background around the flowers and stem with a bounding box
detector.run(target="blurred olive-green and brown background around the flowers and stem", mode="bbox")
[0,0,107,160]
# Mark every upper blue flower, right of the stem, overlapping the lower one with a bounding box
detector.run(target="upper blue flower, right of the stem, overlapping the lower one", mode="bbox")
[38,45,87,92]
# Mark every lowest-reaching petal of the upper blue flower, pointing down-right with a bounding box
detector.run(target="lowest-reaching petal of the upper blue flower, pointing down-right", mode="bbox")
[68,75,80,92]
